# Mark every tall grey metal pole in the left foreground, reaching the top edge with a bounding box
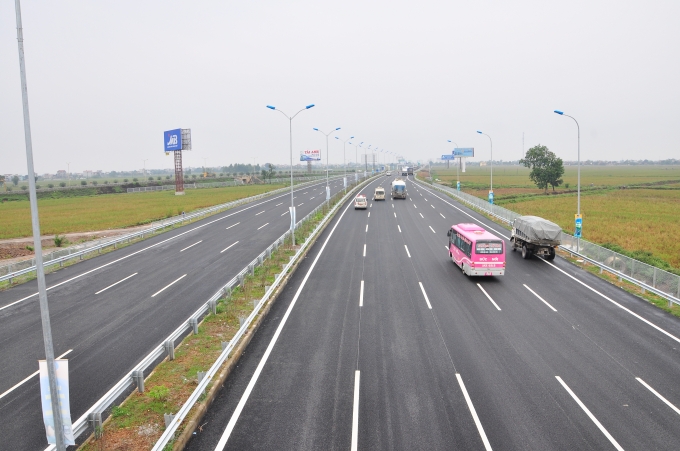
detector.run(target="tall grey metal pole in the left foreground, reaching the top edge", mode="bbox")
[14,0,66,451]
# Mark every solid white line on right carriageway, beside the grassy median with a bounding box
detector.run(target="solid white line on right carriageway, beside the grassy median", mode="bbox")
[215,192,352,451]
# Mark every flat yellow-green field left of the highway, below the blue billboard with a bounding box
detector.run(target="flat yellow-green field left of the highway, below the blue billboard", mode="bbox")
[0,185,283,239]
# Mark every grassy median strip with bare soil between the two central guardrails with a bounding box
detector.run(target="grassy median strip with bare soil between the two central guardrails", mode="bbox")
[79,181,358,451]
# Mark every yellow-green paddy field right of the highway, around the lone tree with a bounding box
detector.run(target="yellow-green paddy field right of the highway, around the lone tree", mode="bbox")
[433,166,680,268]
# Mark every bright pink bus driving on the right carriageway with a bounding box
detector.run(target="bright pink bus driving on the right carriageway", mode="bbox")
[447,223,505,276]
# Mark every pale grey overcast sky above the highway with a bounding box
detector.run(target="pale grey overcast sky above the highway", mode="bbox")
[0,0,680,174]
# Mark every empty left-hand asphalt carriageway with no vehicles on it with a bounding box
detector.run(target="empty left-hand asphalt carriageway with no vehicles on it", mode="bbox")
[0,179,358,451]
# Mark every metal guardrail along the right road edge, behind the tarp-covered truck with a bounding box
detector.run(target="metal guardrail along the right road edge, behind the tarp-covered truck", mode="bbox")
[414,177,680,307]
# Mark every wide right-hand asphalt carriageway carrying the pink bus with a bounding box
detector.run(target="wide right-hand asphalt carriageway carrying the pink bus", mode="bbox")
[187,178,680,451]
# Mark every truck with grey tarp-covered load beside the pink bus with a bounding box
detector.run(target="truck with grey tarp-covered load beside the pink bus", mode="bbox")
[510,216,562,260]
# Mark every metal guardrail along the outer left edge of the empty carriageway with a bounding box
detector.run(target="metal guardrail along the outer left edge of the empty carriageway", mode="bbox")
[0,177,346,282]
